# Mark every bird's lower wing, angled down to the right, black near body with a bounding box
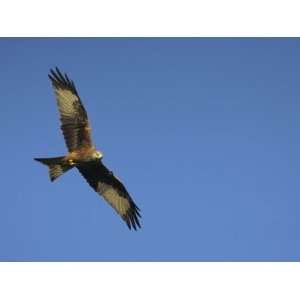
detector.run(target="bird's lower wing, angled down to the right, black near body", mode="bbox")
[77,162,141,230]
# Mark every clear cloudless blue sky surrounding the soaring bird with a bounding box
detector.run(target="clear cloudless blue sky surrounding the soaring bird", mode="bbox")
[0,38,300,261]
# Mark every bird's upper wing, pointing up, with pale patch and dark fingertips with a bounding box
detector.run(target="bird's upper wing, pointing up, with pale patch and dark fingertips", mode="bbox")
[48,68,93,152]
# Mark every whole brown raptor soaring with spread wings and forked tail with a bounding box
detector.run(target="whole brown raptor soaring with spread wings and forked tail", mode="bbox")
[35,67,141,230]
